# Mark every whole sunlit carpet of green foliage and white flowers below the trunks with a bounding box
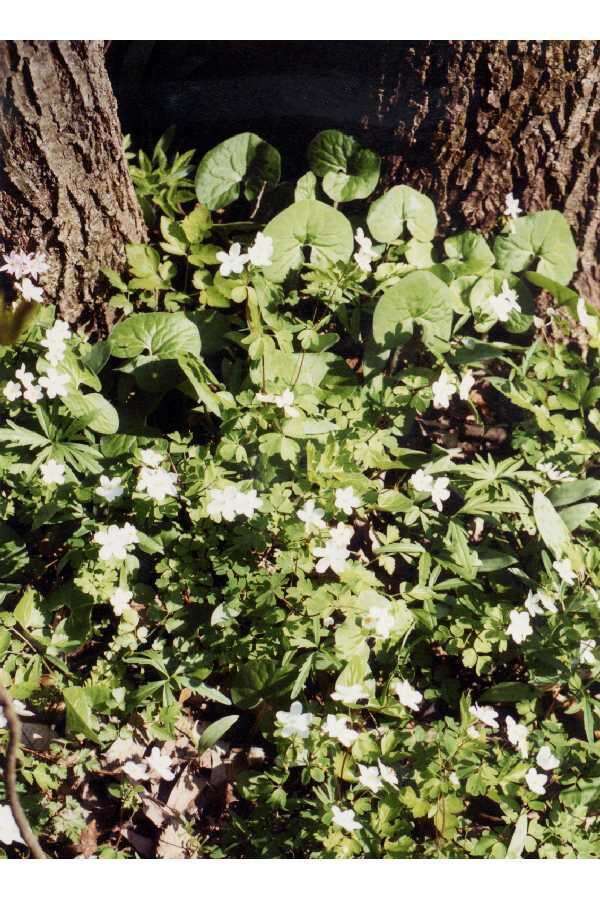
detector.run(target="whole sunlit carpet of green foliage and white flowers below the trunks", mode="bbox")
[0,130,600,858]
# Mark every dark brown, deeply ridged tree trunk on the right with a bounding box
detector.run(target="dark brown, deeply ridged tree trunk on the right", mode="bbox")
[362,41,600,305]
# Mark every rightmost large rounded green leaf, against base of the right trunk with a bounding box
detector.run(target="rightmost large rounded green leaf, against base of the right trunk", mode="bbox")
[494,210,577,284]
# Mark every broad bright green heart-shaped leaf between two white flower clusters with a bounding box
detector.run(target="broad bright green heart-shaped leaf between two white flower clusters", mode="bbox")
[264,200,354,282]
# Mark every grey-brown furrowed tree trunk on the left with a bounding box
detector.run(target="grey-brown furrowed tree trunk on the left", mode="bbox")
[0,41,145,331]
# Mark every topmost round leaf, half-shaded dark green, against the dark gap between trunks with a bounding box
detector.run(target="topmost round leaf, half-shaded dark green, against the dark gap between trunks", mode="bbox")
[308,129,381,202]
